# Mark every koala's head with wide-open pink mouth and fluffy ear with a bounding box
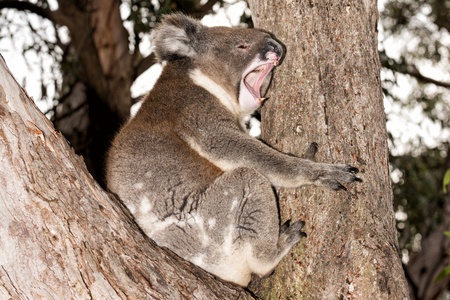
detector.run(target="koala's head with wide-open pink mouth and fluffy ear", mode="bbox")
[154,14,284,111]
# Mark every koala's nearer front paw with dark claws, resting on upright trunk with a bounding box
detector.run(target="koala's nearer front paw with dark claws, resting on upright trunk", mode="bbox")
[312,164,362,191]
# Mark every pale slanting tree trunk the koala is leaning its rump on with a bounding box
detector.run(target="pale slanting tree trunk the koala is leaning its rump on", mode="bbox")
[0,56,251,299]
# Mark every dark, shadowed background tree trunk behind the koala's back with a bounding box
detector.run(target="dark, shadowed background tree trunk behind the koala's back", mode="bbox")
[54,0,135,183]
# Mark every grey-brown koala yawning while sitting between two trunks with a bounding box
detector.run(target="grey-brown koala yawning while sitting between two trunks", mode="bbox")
[106,14,361,287]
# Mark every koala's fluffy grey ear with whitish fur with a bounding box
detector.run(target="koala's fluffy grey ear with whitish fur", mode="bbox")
[153,14,204,61]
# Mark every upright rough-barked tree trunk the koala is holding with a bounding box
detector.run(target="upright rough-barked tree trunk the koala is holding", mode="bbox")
[250,0,408,299]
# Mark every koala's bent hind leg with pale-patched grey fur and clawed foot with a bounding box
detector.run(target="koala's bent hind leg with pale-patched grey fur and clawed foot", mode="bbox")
[201,168,305,286]
